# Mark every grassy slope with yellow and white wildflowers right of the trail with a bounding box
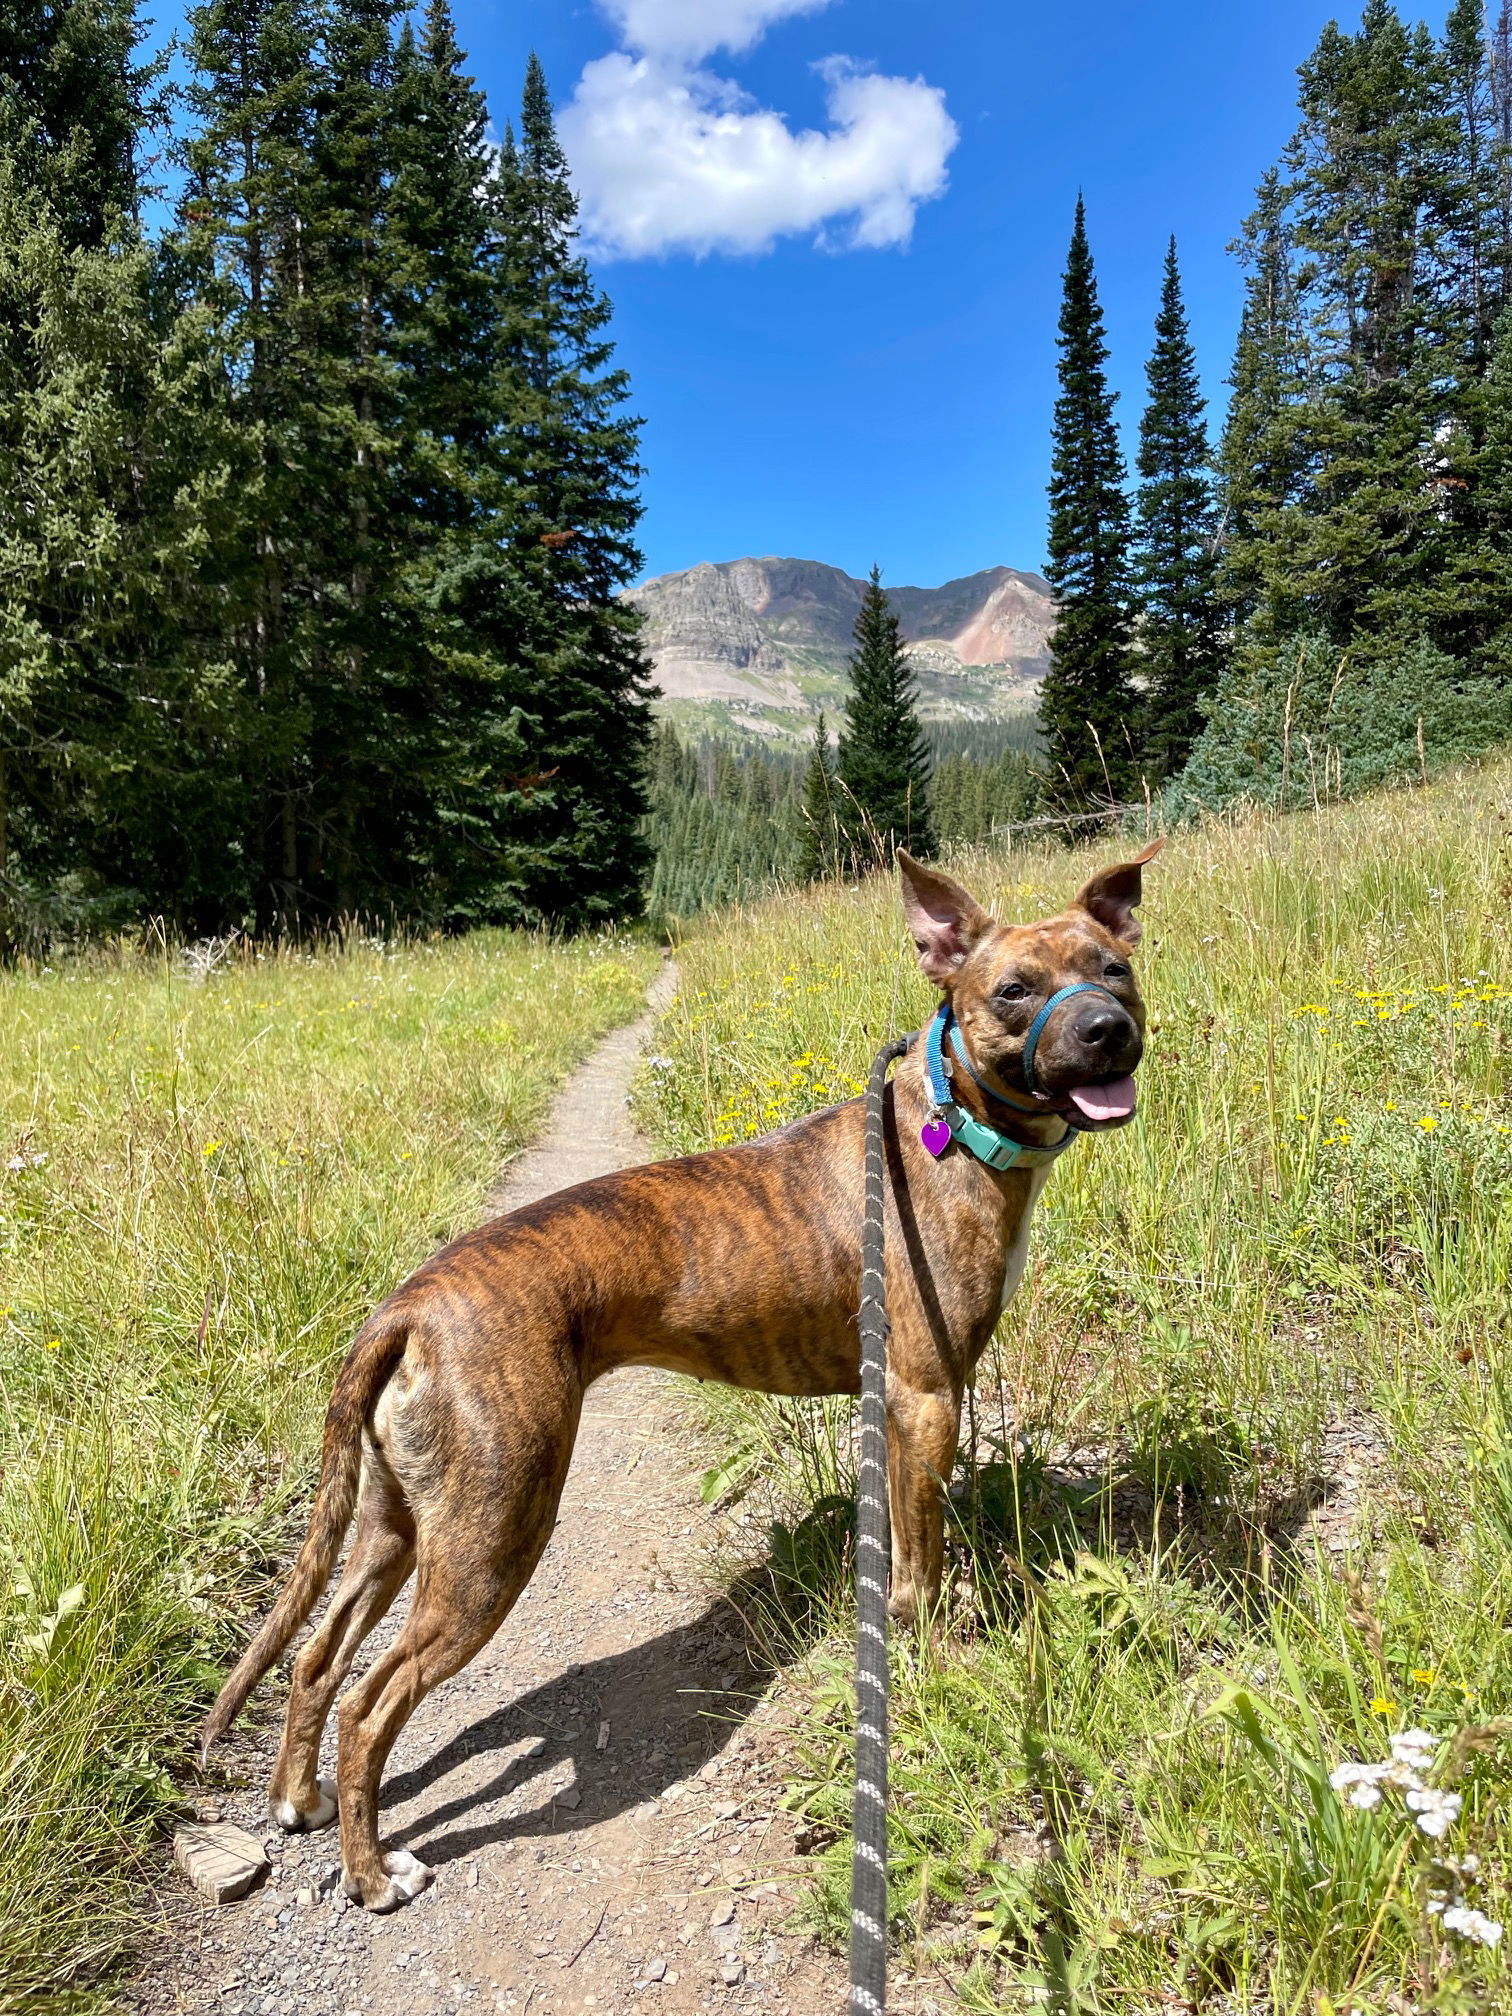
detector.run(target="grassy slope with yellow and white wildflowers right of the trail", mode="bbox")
[641,766,1512,2016]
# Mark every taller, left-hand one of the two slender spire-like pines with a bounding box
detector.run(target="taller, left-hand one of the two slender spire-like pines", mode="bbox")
[1040,198,1135,810]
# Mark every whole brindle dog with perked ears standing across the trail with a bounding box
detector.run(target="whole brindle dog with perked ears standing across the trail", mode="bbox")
[204,847,1155,1911]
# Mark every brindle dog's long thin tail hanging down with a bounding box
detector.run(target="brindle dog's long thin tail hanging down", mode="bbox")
[200,1314,409,1764]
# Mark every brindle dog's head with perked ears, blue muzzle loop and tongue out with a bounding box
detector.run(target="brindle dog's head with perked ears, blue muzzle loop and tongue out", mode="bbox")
[897,841,1163,1129]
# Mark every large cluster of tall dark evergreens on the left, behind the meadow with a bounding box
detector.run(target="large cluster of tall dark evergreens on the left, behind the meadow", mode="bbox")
[0,0,651,946]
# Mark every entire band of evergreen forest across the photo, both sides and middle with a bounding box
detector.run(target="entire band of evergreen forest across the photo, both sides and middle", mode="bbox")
[0,0,1512,952]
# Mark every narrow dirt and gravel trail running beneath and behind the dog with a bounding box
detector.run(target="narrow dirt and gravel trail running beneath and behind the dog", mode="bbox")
[125,972,845,2016]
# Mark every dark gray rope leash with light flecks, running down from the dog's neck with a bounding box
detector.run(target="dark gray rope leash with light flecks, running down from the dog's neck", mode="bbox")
[851,1036,913,2016]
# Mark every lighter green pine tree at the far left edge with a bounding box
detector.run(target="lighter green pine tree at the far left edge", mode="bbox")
[0,161,250,948]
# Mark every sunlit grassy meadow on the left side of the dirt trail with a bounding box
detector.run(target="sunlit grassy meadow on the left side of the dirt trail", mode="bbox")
[0,933,655,2010]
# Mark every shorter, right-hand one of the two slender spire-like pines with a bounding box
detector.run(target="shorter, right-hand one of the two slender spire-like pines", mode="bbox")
[1137,238,1224,778]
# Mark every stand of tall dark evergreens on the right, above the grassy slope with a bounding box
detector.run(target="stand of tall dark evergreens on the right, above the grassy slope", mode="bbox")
[1042,0,1512,816]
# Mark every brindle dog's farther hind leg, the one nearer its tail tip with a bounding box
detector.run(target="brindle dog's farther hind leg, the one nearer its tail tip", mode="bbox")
[268,1441,415,1833]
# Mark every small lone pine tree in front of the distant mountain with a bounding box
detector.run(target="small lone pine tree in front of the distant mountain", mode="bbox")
[837,566,935,865]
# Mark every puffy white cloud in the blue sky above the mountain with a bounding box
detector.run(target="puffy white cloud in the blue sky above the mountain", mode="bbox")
[560,0,960,258]
